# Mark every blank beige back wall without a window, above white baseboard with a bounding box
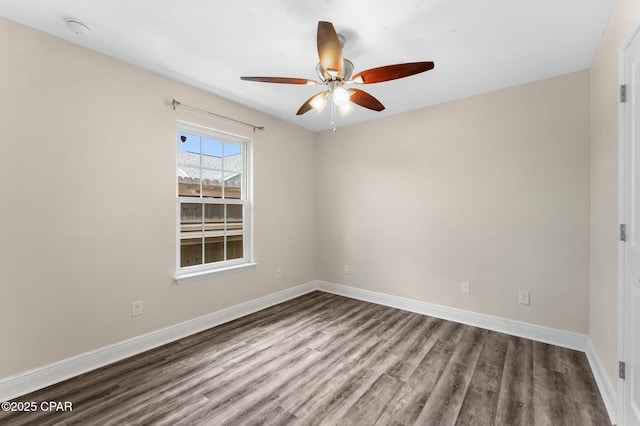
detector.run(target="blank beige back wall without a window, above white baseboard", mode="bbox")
[317,71,589,334]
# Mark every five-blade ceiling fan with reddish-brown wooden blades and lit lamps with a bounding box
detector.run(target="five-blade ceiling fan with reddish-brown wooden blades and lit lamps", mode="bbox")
[240,21,434,115]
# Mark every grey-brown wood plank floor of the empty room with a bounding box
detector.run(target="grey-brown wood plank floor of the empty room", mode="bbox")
[0,291,610,426]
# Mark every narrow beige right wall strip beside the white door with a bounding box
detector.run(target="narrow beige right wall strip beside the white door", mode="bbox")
[589,0,640,384]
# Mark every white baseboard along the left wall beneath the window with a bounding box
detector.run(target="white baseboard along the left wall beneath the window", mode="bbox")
[0,281,317,402]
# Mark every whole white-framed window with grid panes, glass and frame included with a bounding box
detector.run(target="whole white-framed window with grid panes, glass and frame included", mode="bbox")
[176,122,254,282]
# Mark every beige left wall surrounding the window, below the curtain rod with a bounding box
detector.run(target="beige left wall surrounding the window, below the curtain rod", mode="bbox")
[0,19,316,377]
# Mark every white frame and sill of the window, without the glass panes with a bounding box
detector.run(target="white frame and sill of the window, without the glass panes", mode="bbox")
[174,121,256,284]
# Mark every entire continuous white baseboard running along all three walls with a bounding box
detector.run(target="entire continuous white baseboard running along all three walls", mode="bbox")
[0,281,617,424]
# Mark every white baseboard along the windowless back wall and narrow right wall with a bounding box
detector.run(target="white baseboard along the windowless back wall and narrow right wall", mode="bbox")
[316,281,618,424]
